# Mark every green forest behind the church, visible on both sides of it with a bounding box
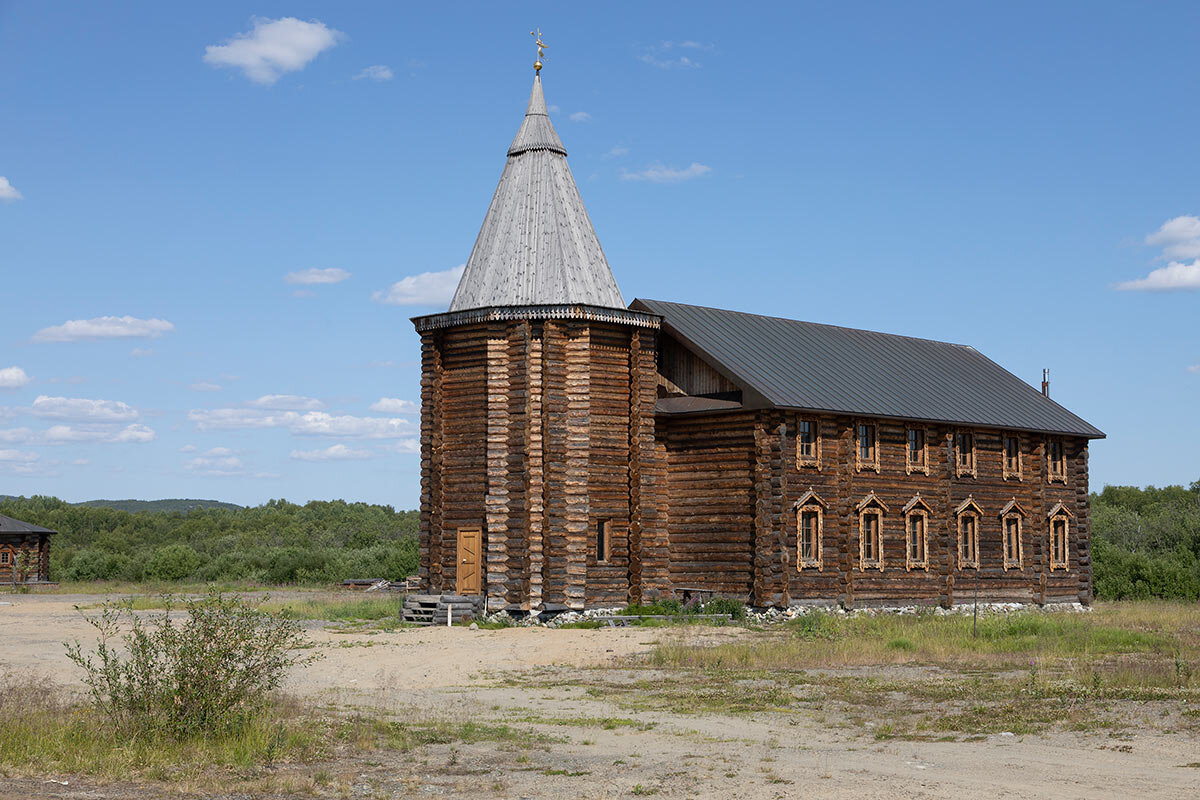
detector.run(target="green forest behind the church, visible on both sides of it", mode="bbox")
[0,481,1200,601]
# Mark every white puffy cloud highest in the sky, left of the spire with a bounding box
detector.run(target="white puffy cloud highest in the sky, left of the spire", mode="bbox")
[204,17,344,85]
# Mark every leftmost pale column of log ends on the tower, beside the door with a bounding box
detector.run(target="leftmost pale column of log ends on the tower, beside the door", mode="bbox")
[484,326,509,607]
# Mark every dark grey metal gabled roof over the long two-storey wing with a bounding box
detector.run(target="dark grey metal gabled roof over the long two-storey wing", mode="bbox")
[630,299,1104,439]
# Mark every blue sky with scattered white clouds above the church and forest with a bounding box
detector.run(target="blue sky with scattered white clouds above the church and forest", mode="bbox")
[0,1,1200,507]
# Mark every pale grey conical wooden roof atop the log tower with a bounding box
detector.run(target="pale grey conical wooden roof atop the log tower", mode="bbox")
[450,77,625,311]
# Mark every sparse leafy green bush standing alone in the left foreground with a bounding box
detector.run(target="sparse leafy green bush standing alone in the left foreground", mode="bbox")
[66,591,318,739]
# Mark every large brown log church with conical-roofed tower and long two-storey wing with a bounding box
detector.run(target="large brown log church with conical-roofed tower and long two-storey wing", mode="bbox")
[413,62,1104,612]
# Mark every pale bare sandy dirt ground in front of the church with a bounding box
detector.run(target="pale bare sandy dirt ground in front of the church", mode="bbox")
[0,595,1200,800]
